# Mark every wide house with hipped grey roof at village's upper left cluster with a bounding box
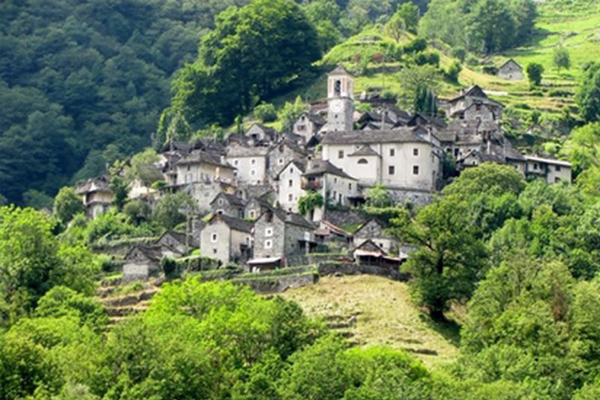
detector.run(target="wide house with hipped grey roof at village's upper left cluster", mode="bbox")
[177,150,235,185]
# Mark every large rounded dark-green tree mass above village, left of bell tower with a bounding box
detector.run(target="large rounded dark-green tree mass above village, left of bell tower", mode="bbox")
[173,0,321,131]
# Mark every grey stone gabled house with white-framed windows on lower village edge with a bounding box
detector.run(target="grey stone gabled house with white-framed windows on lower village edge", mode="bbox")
[248,207,316,269]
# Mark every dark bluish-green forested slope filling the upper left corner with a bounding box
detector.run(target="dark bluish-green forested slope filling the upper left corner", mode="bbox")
[0,0,254,202]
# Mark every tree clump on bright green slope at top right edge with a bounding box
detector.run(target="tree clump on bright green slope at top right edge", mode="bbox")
[420,0,536,54]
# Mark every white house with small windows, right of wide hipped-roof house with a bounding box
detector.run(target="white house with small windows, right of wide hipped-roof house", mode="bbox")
[225,143,269,184]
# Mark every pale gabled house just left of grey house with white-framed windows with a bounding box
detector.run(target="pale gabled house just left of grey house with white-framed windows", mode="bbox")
[200,214,252,265]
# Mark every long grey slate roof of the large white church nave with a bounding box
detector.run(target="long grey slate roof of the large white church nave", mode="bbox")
[322,127,427,144]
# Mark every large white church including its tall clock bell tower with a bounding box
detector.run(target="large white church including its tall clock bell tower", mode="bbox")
[321,66,443,204]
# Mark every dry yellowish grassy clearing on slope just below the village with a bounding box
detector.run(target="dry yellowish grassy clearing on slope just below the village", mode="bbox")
[283,275,458,366]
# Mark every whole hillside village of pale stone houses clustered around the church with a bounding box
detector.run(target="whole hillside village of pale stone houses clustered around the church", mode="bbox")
[77,62,571,281]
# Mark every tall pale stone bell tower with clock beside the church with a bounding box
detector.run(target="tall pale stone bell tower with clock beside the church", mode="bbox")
[327,65,354,132]
